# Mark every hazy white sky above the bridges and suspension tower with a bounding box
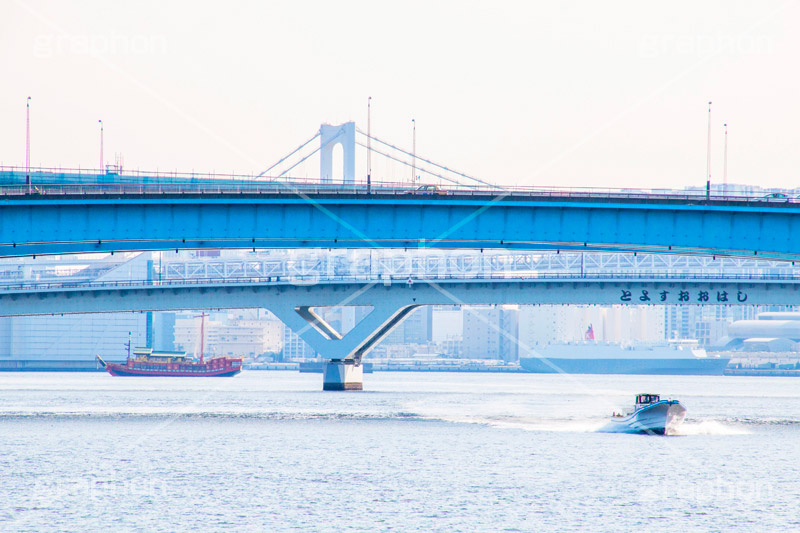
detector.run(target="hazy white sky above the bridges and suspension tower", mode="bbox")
[0,0,800,187]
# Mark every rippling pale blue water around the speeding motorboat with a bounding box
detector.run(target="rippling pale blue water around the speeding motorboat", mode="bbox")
[0,372,800,531]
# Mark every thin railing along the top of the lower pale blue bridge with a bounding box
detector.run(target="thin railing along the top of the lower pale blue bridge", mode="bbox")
[0,273,800,293]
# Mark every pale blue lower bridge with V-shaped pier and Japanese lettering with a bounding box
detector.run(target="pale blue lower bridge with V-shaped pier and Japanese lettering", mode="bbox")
[0,273,800,362]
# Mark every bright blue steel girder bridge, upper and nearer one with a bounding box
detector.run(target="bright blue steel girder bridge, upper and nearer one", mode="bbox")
[0,179,800,260]
